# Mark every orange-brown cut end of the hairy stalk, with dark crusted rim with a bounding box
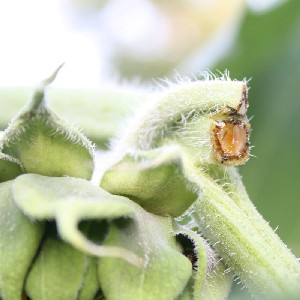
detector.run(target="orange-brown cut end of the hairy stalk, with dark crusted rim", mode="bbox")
[212,119,249,165]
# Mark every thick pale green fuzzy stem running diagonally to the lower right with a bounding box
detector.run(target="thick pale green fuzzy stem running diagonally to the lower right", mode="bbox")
[185,158,300,299]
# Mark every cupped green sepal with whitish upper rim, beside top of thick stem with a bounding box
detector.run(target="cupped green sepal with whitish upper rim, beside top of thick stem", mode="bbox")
[100,147,197,217]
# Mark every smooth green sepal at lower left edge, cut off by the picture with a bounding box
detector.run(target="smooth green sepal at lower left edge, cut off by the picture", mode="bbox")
[0,181,44,300]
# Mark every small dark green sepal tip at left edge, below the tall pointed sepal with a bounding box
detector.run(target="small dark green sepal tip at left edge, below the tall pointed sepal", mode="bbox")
[0,153,24,182]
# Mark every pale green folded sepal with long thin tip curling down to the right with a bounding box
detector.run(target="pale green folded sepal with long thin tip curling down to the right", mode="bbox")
[12,174,140,265]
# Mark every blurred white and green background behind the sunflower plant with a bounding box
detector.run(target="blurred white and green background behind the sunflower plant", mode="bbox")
[0,0,300,299]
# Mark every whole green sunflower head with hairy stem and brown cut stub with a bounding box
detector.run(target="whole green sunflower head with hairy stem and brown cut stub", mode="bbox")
[0,71,300,300]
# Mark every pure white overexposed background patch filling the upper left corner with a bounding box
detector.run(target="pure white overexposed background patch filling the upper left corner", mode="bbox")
[0,0,101,87]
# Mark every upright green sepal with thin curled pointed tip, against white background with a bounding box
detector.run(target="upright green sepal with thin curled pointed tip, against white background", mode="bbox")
[0,69,93,179]
